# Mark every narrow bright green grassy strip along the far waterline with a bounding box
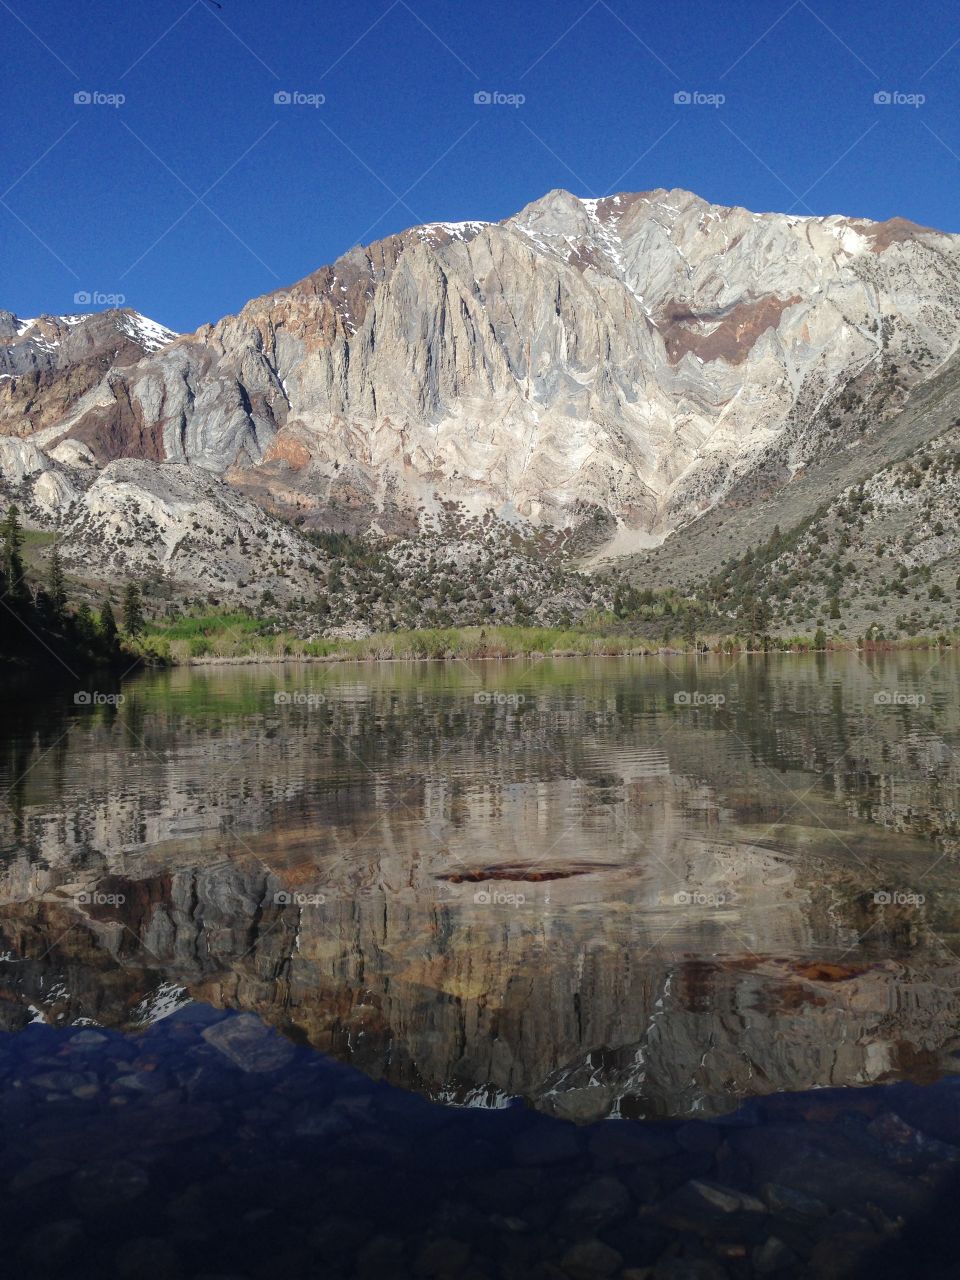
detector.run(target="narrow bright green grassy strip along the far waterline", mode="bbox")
[133,613,957,666]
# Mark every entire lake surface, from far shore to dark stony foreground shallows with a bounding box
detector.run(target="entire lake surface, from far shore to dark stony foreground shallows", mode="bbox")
[0,653,960,1280]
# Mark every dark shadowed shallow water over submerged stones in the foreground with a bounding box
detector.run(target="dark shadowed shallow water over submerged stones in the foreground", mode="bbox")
[0,1005,960,1280]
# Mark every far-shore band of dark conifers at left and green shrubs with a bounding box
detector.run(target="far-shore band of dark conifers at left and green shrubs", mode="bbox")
[0,506,960,675]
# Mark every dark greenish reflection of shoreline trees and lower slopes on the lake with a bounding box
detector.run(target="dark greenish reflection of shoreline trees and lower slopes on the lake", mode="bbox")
[3,655,960,875]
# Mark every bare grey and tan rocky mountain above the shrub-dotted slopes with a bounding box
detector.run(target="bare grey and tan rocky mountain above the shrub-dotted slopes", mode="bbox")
[0,189,960,624]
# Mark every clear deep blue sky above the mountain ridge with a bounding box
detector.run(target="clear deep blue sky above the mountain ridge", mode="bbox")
[0,0,960,330]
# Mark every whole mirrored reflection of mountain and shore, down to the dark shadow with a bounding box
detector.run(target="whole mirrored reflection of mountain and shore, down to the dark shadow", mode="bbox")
[0,654,960,1121]
